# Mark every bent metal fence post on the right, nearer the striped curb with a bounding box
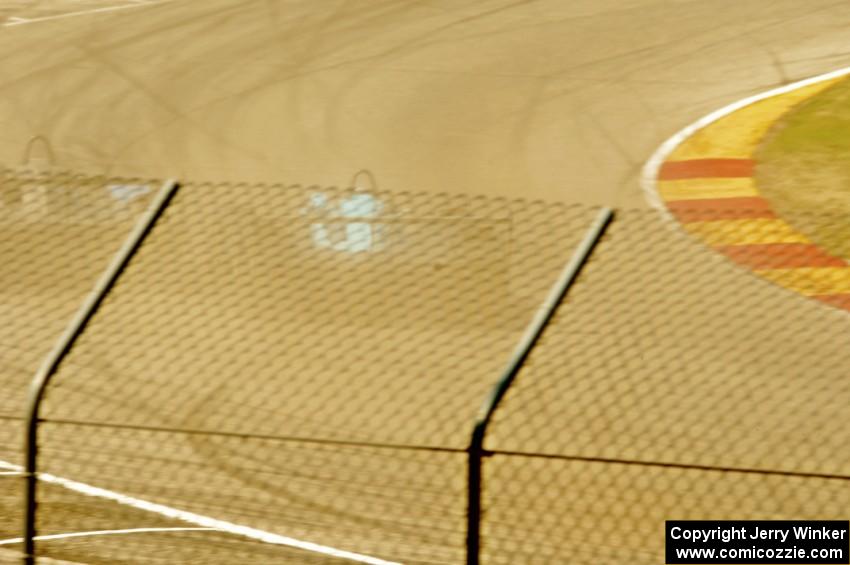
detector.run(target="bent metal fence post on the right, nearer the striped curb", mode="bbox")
[466,208,614,565]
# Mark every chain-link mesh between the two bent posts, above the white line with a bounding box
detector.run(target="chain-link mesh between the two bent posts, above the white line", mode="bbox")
[33,185,594,563]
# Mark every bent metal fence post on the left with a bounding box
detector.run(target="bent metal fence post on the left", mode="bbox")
[23,180,179,565]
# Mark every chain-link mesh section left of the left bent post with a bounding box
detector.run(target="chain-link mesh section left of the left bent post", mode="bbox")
[0,170,160,552]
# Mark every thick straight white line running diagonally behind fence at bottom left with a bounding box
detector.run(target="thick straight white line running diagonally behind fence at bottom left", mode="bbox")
[0,461,401,565]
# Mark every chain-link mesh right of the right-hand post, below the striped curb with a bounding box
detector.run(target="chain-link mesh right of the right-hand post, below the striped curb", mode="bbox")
[482,208,850,564]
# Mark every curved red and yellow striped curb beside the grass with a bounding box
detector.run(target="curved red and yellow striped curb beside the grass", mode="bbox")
[654,76,850,310]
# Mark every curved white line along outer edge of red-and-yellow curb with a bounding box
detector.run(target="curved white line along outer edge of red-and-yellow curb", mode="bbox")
[640,67,850,214]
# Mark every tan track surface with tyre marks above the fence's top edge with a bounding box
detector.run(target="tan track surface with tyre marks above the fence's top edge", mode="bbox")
[0,0,850,206]
